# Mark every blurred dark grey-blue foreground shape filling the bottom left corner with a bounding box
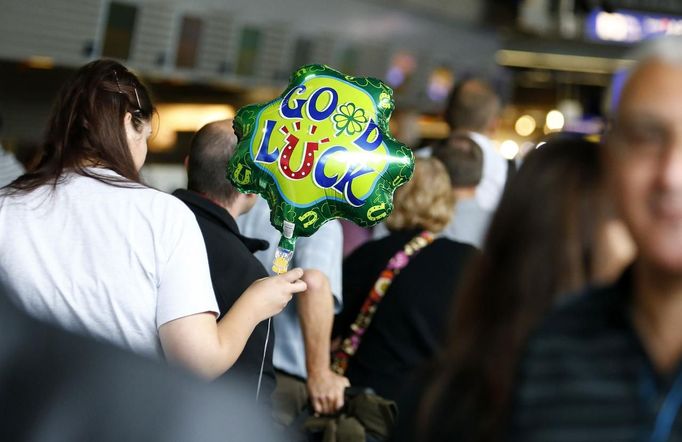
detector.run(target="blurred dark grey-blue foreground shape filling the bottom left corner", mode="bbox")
[0,290,280,442]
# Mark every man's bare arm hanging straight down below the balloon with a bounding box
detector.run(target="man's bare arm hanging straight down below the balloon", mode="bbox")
[296,269,350,414]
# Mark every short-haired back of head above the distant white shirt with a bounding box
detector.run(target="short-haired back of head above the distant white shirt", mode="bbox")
[445,78,501,134]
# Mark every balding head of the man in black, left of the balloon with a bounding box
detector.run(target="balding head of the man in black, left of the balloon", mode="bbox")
[187,120,237,204]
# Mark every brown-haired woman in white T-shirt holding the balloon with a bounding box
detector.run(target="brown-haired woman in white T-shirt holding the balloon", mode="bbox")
[0,60,305,378]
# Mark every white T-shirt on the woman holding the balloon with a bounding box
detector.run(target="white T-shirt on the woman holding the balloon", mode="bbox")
[0,168,218,357]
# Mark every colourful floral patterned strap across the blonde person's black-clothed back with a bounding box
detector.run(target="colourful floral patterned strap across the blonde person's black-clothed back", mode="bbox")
[331,230,434,375]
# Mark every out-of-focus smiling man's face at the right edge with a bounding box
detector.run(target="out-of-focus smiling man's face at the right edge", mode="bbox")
[609,62,682,275]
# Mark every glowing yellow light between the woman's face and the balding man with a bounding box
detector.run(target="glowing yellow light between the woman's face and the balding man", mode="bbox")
[149,103,235,152]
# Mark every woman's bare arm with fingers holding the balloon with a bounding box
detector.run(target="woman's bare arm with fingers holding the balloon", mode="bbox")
[159,269,306,379]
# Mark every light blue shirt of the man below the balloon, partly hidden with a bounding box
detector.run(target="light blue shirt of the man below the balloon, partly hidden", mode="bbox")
[237,197,343,378]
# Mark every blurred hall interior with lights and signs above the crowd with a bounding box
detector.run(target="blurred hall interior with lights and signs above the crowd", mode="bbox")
[0,0,682,190]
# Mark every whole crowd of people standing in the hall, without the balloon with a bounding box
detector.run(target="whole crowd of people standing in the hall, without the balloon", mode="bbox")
[0,38,682,442]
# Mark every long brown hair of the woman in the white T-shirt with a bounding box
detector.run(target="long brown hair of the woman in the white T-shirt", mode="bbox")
[8,60,154,192]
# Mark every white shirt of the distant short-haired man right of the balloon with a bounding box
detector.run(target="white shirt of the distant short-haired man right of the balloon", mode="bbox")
[469,132,509,212]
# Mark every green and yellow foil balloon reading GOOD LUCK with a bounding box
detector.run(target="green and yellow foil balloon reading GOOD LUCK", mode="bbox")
[227,65,414,273]
